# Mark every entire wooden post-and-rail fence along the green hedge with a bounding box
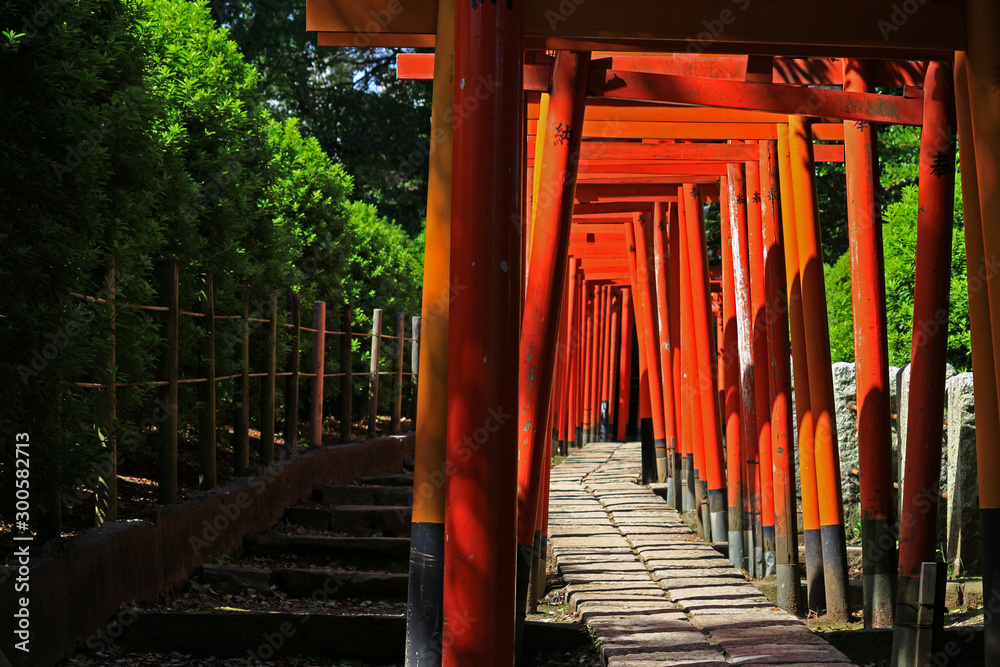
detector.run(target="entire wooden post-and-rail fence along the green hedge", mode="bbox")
[67,262,420,524]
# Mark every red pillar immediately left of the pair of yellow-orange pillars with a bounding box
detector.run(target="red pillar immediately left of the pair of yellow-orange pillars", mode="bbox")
[760,141,804,614]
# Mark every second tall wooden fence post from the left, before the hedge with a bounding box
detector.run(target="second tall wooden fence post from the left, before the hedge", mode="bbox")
[157,262,180,505]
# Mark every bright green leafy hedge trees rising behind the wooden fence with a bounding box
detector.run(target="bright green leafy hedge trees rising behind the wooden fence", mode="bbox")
[0,0,420,524]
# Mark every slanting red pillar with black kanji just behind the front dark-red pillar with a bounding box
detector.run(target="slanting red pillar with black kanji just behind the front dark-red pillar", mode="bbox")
[517,51,590,636]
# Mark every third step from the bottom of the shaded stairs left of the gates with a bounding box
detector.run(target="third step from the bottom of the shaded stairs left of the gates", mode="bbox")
[243,535,410,570]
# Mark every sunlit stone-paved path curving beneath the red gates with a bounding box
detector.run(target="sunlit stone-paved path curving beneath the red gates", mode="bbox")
[549,443,853,667]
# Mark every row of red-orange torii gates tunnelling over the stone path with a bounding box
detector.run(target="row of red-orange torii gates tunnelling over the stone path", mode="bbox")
[308,0,1000,666]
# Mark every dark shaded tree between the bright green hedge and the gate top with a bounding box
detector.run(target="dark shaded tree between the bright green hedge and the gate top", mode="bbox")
[211,0,430,236]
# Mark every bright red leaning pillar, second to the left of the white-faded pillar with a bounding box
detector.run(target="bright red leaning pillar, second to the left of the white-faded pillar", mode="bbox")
[681,183,729,542]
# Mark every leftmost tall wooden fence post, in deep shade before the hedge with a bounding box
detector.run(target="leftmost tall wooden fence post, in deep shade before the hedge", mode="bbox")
[94,258,118,526]
